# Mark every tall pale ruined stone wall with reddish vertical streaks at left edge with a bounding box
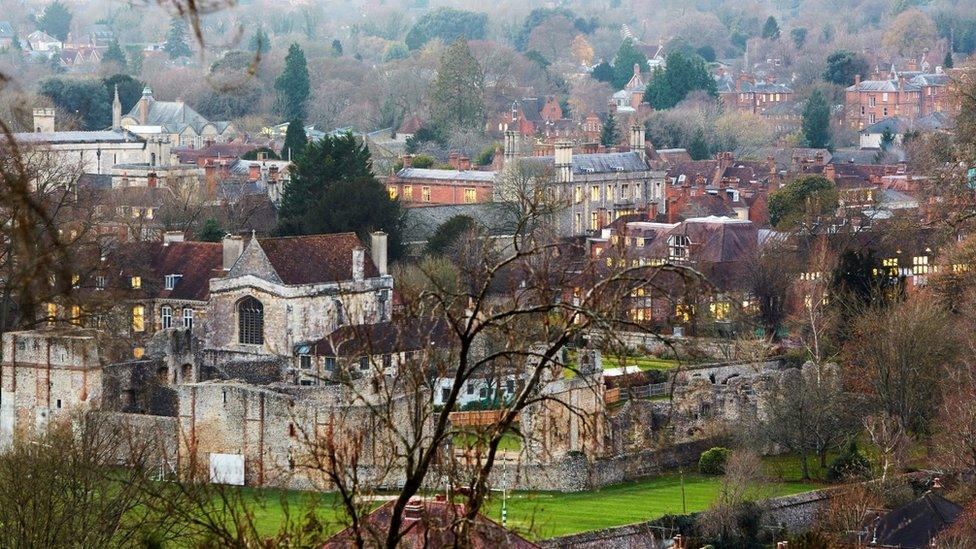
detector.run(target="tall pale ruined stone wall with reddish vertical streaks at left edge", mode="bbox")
[0,327,102,446]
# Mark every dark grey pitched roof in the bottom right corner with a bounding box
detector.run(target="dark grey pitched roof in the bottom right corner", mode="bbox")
[869,492,963,549]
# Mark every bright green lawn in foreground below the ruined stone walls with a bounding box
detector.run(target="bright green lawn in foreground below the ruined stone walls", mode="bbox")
[240,474,818,539]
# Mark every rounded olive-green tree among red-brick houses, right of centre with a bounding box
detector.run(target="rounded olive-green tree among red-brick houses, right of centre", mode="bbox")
[767,175,837,229]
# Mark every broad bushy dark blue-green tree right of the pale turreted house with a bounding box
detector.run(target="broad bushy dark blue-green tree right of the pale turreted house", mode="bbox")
[644,51,718,110]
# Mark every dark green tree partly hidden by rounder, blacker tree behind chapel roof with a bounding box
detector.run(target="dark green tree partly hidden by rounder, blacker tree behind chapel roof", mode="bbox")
[276,134,372,236]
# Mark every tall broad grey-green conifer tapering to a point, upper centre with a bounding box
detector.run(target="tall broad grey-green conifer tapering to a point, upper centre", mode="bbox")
[431,39,485,135]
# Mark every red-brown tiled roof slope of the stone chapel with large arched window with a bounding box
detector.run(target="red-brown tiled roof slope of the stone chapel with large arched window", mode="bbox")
[258,233,379,285]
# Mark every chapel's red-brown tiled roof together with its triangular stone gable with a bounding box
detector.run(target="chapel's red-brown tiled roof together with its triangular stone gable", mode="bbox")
[227,233,379,286]
